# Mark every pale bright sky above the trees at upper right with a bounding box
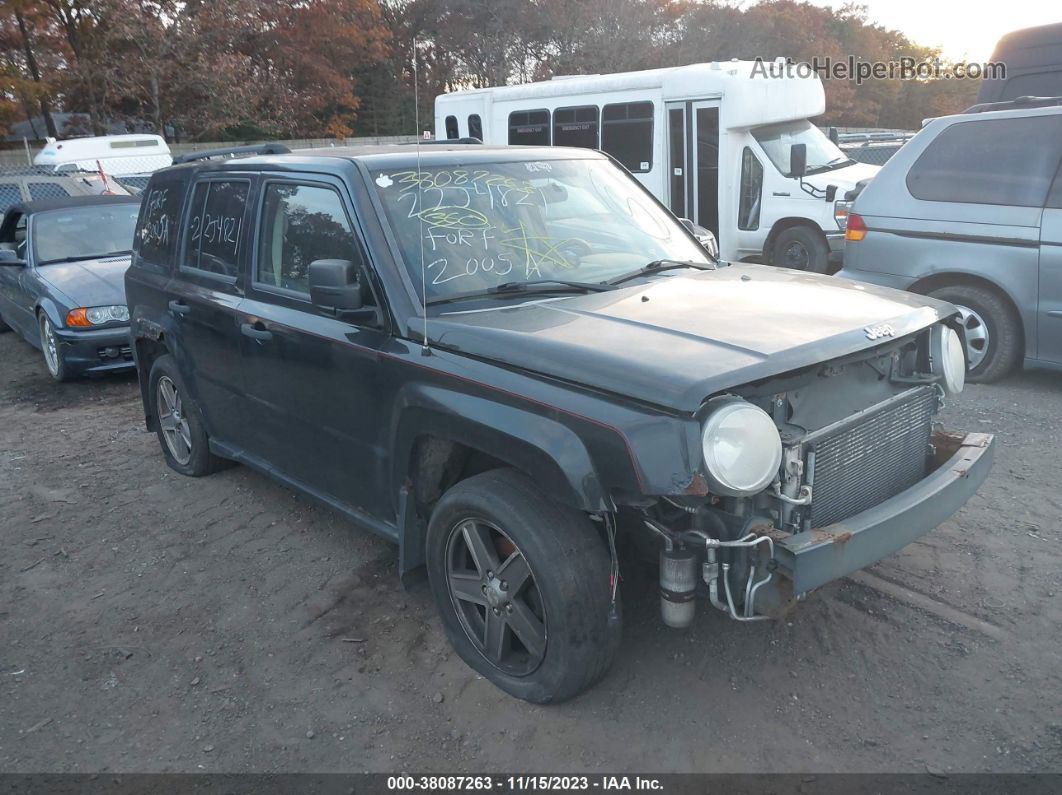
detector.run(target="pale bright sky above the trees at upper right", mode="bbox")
[810,0,1062,63]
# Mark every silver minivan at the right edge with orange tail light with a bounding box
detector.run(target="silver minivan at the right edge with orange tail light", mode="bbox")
[838,98,1062,381]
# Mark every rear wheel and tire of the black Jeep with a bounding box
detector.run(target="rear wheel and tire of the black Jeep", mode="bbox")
[148,353,232,478]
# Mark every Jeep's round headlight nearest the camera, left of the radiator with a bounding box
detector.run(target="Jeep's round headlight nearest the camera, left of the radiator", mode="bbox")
[701,398,782,497]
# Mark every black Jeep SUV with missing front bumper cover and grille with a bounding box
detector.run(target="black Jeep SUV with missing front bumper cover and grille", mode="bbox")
[126,144,992,702]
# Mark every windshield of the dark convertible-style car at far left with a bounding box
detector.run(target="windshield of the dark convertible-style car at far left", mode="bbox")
[33,203,140,264]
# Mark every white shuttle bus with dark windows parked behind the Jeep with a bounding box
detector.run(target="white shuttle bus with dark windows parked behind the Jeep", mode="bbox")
[435,61,878,272]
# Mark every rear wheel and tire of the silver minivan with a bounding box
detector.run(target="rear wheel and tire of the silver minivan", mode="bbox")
[929,284,1022,383]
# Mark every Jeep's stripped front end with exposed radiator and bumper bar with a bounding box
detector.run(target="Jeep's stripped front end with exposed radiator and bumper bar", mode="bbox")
[639,318,993,627]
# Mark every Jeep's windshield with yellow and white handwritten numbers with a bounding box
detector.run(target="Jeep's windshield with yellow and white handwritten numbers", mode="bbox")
[373,160,708,299]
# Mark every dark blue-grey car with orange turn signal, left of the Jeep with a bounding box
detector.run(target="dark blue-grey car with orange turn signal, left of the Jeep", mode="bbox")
[0,196,140,381]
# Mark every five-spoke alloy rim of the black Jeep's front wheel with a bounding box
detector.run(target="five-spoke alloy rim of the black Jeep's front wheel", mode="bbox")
[446,519,546,676]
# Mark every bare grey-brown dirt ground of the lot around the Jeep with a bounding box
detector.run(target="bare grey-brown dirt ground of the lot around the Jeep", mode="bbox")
[0,324,1062,773]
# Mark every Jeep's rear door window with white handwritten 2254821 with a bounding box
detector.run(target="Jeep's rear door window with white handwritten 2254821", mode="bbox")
[185,180,251,278]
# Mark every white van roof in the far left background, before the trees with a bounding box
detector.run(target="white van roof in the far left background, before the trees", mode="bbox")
[33,135,173,176]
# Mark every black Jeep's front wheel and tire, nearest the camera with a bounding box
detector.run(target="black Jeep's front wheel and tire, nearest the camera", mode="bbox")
[427,469,621,704]
